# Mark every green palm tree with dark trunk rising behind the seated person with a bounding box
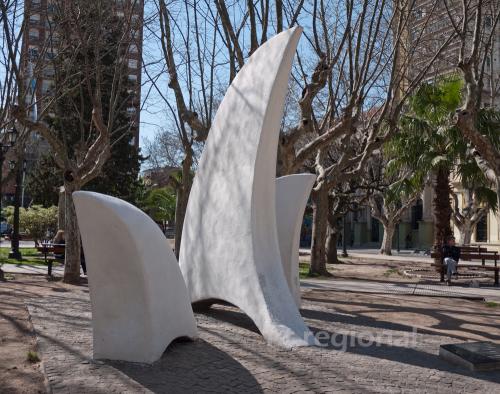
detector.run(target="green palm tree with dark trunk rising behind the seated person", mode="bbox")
[386,78,468,254]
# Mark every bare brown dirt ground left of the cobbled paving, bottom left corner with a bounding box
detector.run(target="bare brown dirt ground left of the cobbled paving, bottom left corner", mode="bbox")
[0,277,46,394]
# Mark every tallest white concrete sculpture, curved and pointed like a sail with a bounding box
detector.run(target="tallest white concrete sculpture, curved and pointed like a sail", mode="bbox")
[180,27,315,348]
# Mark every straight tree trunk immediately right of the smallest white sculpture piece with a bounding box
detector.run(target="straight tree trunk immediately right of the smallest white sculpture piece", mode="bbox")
[309,188,330,276]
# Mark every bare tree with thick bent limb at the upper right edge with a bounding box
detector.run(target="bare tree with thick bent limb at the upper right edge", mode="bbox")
[445,0,500,229]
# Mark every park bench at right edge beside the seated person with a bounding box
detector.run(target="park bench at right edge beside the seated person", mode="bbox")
[431,246,500,286]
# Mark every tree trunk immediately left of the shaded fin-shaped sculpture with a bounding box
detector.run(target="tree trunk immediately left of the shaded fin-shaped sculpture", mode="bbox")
[63,183,81,284]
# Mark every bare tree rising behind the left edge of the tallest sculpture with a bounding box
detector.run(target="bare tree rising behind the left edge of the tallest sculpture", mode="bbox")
[145,0,303,252]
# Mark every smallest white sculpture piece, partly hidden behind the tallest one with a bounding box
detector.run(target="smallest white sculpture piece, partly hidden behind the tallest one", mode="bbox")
[276,174,316,308]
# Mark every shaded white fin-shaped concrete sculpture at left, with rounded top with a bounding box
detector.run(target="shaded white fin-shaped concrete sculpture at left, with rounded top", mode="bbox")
[73,192,197,363]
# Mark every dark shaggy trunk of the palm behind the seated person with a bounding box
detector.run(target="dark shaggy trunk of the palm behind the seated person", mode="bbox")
[433,166,453,264]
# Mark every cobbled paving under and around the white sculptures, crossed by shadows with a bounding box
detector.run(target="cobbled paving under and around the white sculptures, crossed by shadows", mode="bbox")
[6,281,500,394]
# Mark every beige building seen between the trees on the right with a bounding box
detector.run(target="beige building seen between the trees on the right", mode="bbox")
[346,0,500,251]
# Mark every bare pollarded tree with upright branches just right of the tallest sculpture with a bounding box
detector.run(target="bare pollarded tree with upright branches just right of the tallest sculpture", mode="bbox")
[280,1,458,275]
